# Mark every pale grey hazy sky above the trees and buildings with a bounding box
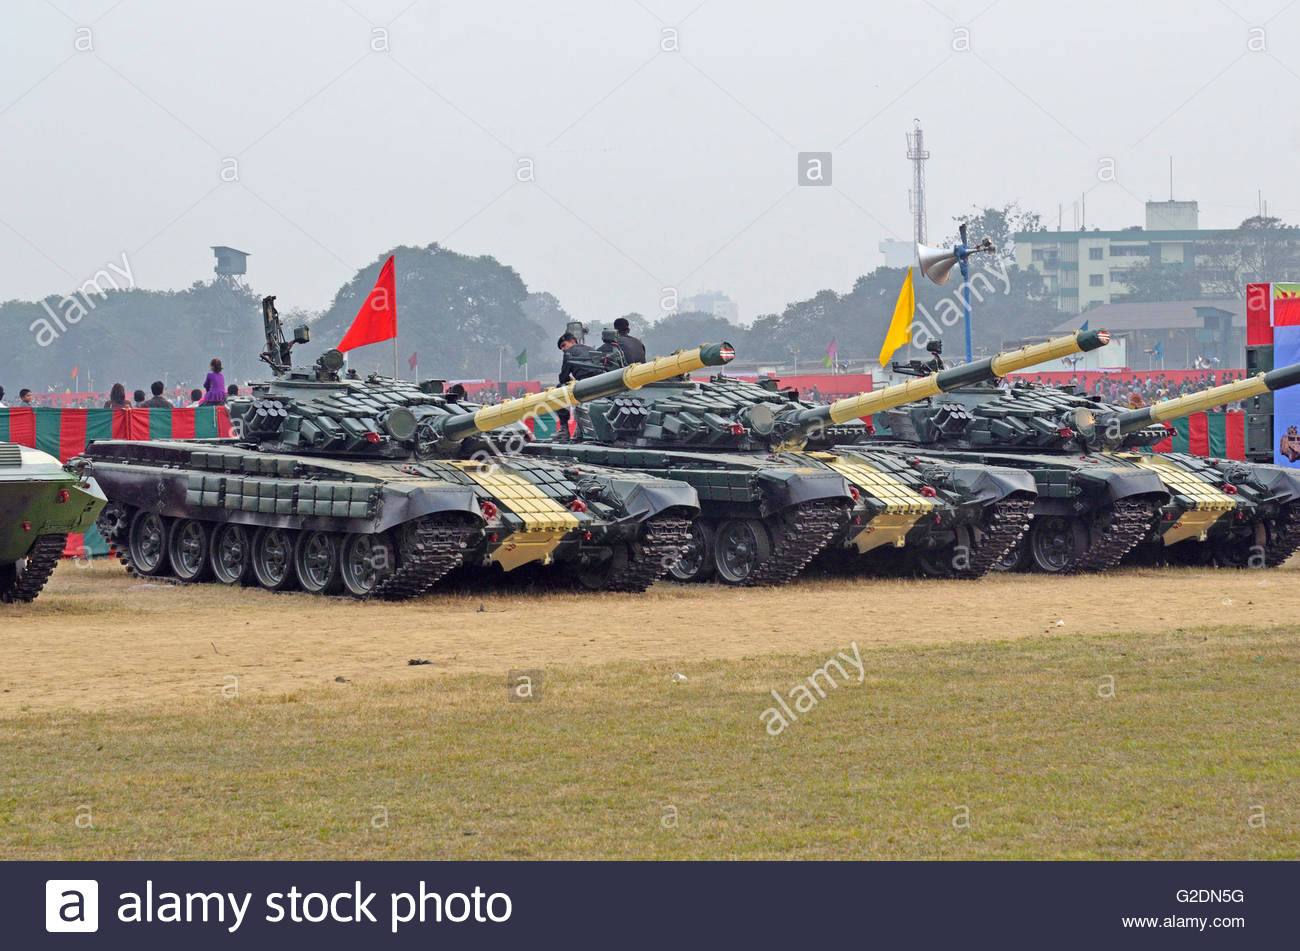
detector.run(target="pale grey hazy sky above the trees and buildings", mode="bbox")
[0,0,1300,320]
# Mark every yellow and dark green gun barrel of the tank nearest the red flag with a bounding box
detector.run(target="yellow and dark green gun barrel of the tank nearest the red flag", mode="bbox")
[439,342,736,439]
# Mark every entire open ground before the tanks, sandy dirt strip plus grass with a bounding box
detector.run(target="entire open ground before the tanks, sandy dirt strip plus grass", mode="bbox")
[0,563,1300,859]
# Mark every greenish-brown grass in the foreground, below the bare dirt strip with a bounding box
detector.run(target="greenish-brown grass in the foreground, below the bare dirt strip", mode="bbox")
[0,625,1300,859]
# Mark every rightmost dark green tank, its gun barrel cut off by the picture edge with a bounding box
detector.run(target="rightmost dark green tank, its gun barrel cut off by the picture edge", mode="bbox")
[872,364,1291,573]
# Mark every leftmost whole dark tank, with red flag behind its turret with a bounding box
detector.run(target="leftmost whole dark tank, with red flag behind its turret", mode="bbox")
[86,298,733,599]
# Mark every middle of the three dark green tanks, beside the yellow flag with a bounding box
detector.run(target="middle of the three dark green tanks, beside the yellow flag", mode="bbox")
[525,331,1109,585]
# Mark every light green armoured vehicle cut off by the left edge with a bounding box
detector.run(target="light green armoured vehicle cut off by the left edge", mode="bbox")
[0,443,105,604]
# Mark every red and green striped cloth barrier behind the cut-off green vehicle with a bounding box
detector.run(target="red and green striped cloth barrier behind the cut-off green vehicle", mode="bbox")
[0,407,230,556]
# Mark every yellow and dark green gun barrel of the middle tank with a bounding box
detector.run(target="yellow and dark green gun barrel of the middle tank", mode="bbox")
[787,330,1110,443]
